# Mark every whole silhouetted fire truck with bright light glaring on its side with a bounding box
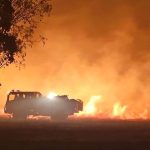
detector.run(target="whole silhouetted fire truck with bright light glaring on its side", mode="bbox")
[4,90,83,120]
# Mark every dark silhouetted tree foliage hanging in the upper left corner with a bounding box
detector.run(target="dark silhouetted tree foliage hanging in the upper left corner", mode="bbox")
[0,0,52,67]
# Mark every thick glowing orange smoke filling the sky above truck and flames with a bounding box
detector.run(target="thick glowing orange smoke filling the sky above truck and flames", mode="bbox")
[0,0,150,116]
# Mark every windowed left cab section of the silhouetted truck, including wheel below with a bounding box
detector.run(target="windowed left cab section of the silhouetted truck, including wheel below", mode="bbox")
[4,90,42,118]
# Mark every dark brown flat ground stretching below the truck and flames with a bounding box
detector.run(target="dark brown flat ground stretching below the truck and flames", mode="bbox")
[0,119,150,150]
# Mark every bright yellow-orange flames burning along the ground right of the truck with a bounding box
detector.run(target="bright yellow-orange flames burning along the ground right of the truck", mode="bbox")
[73,95,148,119]
